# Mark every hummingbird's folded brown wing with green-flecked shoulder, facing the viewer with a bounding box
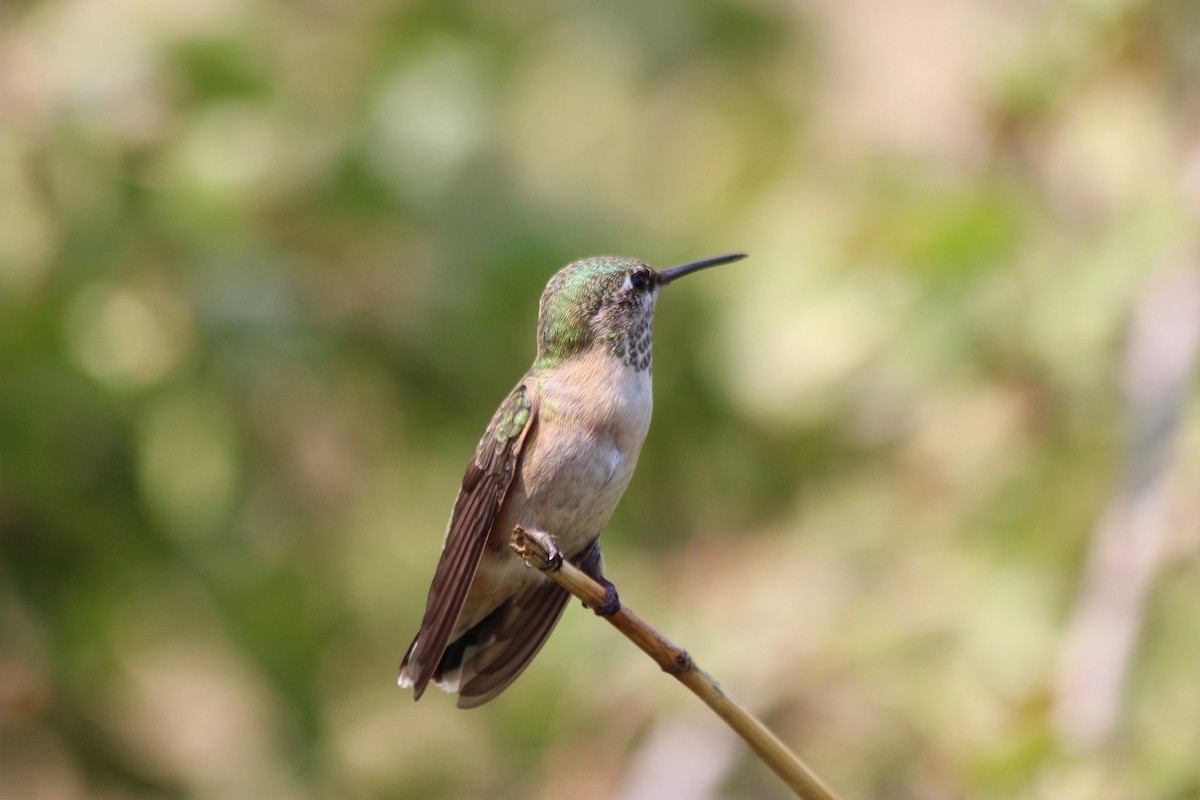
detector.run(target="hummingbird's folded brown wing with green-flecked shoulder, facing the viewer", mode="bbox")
[400,384,538,699]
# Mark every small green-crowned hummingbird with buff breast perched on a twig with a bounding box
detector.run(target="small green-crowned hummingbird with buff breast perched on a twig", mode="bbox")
[400,254,745,709]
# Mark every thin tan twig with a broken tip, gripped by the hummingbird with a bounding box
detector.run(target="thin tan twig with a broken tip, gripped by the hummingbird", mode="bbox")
[511,525,838,800]
